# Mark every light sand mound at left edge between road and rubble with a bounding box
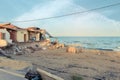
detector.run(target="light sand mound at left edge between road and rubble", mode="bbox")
[0,57,31,70]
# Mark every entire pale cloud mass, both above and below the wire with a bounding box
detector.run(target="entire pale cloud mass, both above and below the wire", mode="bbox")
[14,0,120,36]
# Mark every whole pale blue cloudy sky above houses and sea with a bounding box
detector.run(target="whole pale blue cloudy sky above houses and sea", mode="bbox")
[0,0,120,36]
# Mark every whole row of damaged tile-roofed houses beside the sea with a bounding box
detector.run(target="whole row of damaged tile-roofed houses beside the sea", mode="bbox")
[0,23,51,43]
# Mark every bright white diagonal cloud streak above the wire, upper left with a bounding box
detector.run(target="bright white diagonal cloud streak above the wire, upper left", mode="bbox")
[16,0,69,21]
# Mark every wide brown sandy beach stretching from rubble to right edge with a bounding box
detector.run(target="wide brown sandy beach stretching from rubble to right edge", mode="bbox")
[8,48,120,80]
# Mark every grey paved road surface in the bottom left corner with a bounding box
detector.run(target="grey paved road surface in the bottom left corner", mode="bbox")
[0,71,26,80]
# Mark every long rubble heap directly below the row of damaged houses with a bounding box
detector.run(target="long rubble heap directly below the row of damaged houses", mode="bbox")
[0,39,64,57]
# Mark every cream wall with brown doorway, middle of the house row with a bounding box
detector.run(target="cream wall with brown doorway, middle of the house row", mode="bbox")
[17,30,28,42]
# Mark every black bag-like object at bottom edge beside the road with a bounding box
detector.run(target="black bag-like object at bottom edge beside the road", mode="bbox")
[25,70,43,80]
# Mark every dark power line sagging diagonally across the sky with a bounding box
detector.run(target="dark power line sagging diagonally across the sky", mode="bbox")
[1,3,120,23]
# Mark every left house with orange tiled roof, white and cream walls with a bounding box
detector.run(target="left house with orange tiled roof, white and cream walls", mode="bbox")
[1,23,28,42]
